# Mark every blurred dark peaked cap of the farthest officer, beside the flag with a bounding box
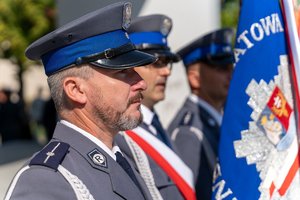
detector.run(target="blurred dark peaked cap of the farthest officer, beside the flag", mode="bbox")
[177,28,234,67]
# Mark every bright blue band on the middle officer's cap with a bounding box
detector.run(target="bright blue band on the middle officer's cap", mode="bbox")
[130,32,168,46]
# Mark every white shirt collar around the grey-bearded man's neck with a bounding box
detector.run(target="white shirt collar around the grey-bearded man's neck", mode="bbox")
[60,120,122,160]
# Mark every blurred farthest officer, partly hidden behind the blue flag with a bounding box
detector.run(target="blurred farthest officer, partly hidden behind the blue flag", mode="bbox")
[168,29,234,200]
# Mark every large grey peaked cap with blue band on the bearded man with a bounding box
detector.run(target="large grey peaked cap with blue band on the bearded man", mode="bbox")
[25,2,156,76]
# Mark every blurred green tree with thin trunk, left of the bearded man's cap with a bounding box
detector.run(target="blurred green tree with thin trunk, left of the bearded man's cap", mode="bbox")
[0,0,55,100]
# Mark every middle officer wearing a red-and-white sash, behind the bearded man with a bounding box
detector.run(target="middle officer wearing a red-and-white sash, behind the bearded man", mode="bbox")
[116,14,195,200]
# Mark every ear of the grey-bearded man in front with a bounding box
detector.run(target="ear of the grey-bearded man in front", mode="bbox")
[63,77,87,104]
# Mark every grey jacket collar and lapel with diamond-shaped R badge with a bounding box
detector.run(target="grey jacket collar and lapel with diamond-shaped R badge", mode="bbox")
[53,123,150,200]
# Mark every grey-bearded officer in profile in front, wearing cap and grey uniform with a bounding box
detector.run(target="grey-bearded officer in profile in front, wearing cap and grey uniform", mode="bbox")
[6,3,156,200]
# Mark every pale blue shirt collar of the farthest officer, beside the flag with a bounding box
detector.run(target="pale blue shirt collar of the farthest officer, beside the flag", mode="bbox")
[189,94,223,126]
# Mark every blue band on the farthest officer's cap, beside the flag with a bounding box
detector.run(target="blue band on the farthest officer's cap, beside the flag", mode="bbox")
[182,44,230,65]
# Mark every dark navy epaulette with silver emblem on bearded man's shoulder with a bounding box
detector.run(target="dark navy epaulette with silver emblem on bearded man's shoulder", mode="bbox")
[29,141,70,170]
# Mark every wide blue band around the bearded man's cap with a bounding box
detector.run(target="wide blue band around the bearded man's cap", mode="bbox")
[42,30,131,76]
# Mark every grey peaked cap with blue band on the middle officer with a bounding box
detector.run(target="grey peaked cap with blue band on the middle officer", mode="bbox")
[128,14,180,62]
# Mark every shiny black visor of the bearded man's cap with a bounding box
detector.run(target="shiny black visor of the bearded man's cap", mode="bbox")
[91,50,157,69]
